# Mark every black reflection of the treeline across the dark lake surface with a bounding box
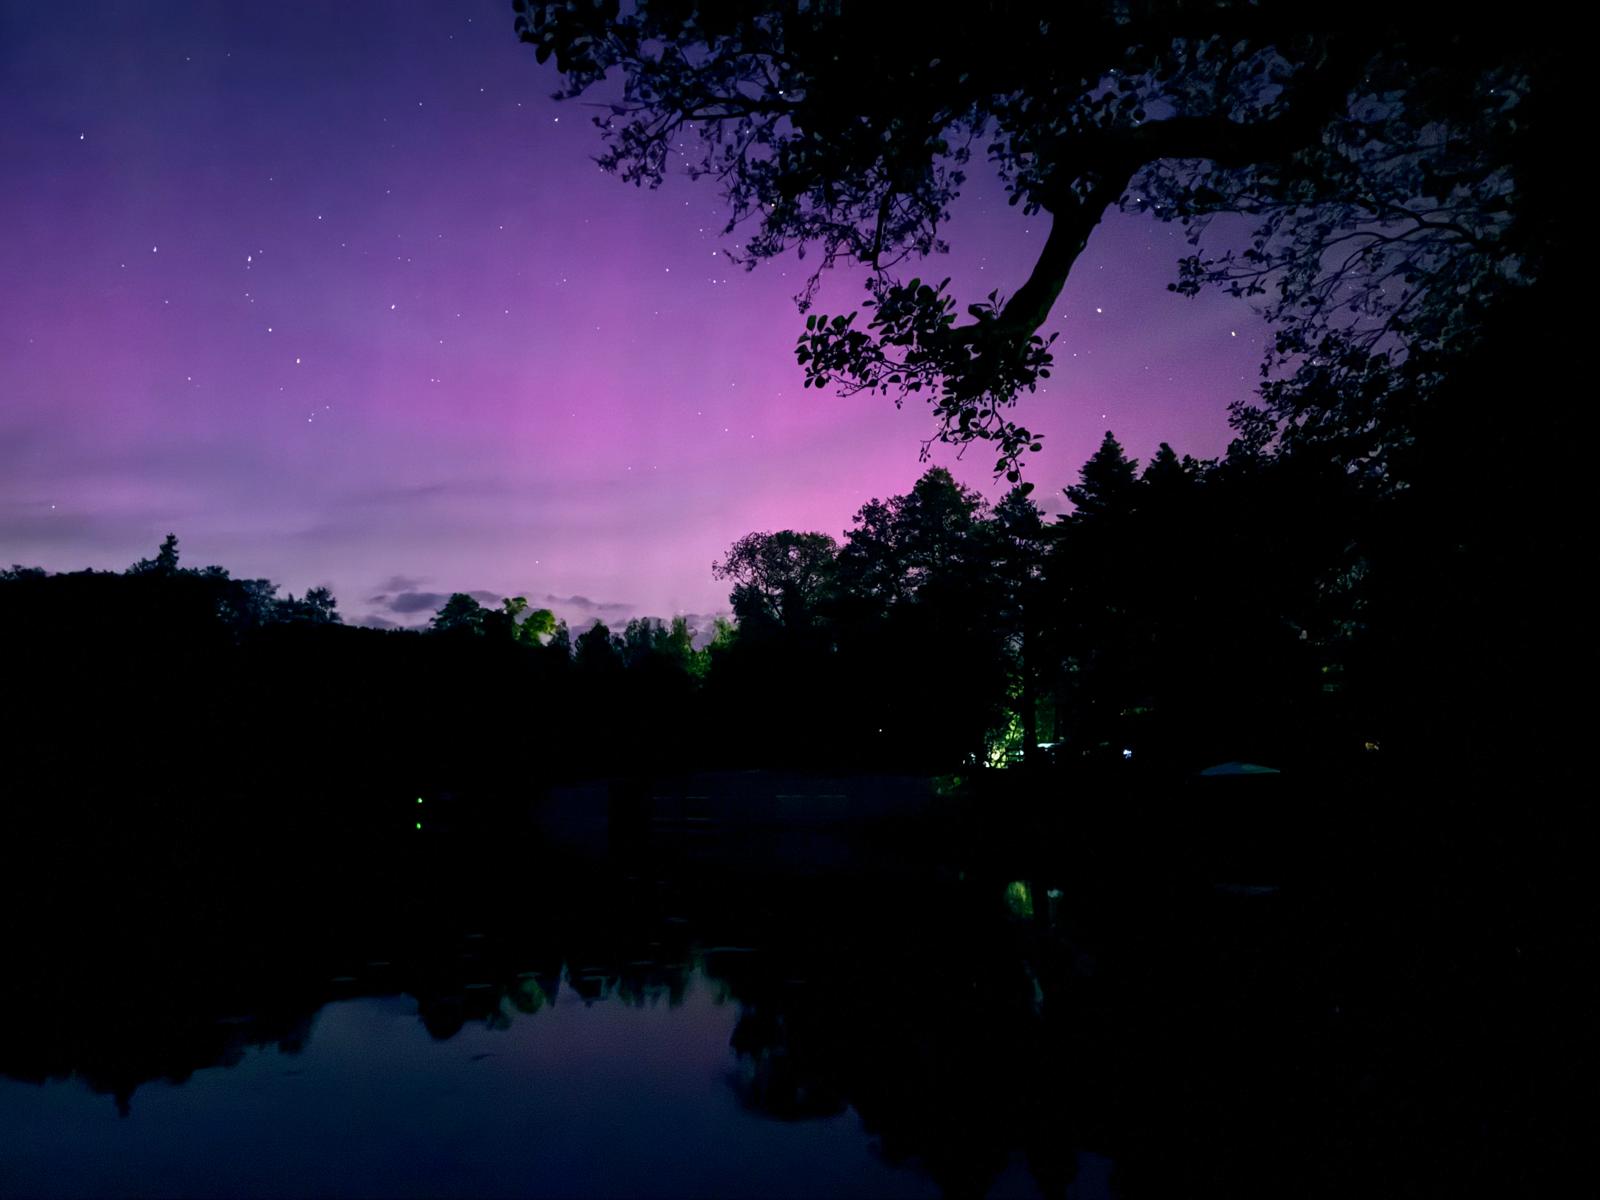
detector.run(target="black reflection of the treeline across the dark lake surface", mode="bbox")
[0,858,1536,1197]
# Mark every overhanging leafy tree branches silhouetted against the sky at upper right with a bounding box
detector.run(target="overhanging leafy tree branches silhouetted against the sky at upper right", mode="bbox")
[514,0,1573,480]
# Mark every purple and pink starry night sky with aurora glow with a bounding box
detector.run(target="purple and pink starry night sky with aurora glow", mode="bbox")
[0,0,1262,624]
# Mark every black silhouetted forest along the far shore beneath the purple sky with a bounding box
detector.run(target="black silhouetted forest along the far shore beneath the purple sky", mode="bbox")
[0,297,1578,838]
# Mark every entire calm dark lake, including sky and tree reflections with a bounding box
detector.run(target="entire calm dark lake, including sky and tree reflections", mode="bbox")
[0,784,1548,1198]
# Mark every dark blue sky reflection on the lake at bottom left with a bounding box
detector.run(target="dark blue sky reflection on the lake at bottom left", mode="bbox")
[0,971,998,1197]
